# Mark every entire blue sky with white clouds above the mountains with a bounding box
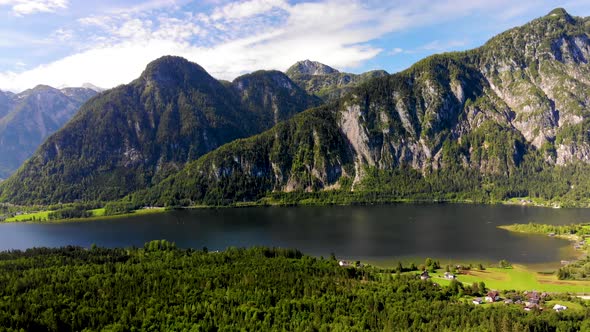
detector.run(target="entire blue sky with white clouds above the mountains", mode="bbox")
[0,0,590,92]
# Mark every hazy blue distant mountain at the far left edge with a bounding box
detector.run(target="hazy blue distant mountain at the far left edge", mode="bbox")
[0,85,96,179]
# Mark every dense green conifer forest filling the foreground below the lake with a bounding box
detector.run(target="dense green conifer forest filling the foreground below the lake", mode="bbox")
[0,241,590,331]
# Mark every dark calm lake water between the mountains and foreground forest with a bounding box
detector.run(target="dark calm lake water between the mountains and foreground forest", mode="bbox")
[0,204,590,264]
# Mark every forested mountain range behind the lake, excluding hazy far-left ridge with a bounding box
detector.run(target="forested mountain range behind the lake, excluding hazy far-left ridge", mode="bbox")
[0,9,590,205]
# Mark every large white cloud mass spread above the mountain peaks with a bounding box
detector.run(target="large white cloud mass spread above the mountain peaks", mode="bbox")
[0,0,588,91]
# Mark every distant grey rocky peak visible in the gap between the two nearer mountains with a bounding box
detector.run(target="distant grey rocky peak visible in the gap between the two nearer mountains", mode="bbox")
[286,60,388,101]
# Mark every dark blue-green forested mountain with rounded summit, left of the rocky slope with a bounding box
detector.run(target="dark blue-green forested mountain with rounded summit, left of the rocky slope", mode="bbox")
[0,56,321,203]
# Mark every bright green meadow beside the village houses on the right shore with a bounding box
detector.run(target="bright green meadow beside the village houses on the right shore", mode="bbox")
[433,265,590,294]
